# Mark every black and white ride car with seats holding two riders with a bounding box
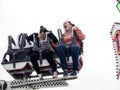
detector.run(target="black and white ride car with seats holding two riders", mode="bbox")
[1,29,83,79]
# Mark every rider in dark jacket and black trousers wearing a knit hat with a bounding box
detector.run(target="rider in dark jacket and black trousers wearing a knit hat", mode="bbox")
[28,26,58,79]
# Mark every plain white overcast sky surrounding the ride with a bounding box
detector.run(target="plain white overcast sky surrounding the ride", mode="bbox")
[0,0,120,90]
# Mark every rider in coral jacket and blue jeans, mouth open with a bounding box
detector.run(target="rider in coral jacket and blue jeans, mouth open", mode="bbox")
[57,21,85,77]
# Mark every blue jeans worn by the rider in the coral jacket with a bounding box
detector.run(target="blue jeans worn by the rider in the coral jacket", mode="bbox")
[57,44,80,71]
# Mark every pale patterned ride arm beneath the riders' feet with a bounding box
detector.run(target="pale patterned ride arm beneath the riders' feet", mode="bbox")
[0,76,77,90]
